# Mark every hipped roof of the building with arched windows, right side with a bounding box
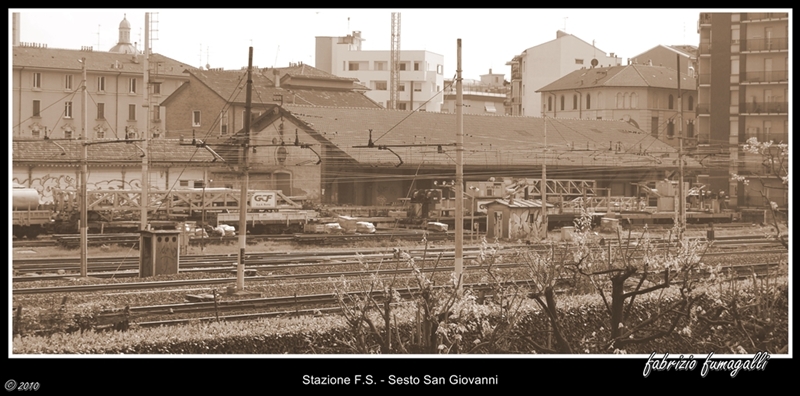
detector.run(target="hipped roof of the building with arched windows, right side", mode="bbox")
[536,65,694,92]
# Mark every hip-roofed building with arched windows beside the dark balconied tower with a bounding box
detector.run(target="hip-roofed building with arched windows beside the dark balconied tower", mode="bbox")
[539,64,697,147]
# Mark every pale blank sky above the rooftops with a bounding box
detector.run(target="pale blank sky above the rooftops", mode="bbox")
[8,8,719,79]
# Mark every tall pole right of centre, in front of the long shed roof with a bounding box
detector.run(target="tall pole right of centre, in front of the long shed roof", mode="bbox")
[454,39,464,294]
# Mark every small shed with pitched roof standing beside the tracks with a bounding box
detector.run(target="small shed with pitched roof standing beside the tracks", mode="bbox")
[484,199,553,240]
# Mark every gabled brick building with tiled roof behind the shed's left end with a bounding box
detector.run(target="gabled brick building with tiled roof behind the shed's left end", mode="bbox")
[161,65,380,141]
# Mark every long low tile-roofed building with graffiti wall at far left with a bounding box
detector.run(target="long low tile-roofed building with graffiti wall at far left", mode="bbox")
[12,139,223,203]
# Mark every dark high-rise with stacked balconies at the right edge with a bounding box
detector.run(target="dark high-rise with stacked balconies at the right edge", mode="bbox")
[697,12,790,207]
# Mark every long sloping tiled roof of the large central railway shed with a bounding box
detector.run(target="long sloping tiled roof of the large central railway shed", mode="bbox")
[283,105,694,168]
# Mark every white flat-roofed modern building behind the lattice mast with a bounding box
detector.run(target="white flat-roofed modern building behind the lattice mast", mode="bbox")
[314,31,444,111]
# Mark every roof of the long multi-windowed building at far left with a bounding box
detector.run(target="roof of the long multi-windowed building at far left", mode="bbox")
[11,46,194,77]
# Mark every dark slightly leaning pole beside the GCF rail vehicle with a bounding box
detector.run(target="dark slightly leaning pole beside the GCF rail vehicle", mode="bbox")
[236,47,253,292]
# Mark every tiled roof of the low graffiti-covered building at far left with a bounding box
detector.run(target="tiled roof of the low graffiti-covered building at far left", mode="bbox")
[12,139,215,165]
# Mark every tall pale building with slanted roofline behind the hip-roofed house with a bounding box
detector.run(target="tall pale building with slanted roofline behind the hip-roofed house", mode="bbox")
[506,30,622,117]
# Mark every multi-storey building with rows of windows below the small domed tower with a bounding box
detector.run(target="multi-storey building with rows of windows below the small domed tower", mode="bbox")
[11,44,193,139]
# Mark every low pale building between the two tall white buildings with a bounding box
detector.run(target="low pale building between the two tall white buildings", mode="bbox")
[441,69,511,115]
